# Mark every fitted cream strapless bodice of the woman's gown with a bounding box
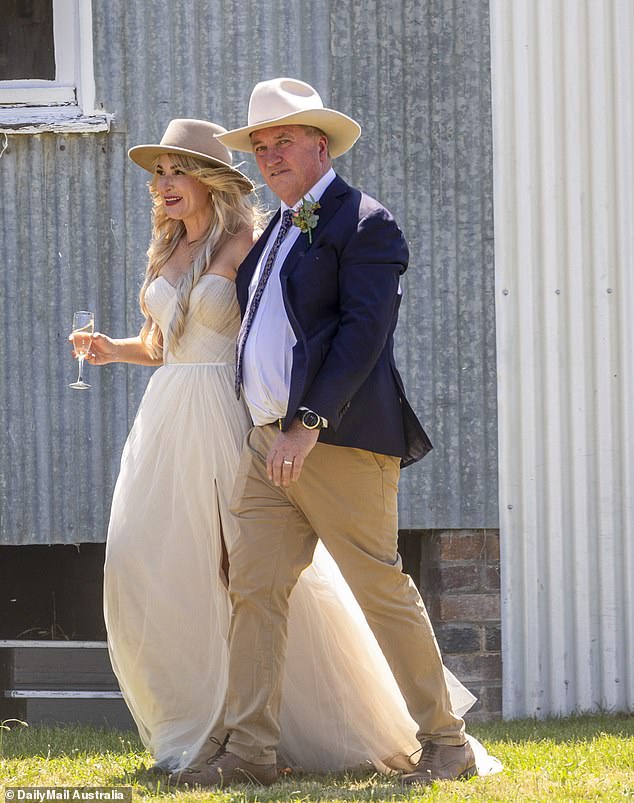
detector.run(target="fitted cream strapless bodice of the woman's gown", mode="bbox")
[145,273,240,365]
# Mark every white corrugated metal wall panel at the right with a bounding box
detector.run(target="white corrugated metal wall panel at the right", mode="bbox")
[491,0,634,717]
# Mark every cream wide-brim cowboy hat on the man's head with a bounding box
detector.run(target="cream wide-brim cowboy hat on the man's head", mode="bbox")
[217,78,361,158]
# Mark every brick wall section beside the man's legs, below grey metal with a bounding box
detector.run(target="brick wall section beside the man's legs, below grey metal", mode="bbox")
[401,530,502,722]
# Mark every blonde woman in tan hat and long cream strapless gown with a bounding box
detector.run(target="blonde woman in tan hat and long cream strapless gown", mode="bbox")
[89,120,496,771]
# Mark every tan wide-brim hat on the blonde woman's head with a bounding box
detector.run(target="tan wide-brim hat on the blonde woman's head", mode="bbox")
[128,118,254,192]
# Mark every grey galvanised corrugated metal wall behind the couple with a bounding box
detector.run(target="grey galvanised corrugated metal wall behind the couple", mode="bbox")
[0,0,497,543]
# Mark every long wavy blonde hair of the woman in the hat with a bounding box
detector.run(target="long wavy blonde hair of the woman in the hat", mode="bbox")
[139,153,263,359]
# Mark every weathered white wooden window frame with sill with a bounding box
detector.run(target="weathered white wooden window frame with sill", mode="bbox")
[0,0,112,134]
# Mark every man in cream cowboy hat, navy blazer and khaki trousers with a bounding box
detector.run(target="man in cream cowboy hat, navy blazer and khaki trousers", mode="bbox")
[174,78,475,786]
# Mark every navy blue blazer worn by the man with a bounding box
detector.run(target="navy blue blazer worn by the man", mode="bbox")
[236,176,432,466]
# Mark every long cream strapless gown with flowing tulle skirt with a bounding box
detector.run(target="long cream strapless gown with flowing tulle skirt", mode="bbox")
[104,274,499,774]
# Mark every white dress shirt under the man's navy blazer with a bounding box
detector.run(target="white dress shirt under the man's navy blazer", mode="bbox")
[242,168,335,426]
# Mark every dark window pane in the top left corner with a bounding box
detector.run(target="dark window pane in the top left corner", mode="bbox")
[0,0,55,81]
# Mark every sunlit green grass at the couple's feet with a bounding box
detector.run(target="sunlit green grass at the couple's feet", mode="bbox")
[0,714,634,803]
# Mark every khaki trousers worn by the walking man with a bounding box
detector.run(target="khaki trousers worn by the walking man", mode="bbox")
[225,425,465,764]
